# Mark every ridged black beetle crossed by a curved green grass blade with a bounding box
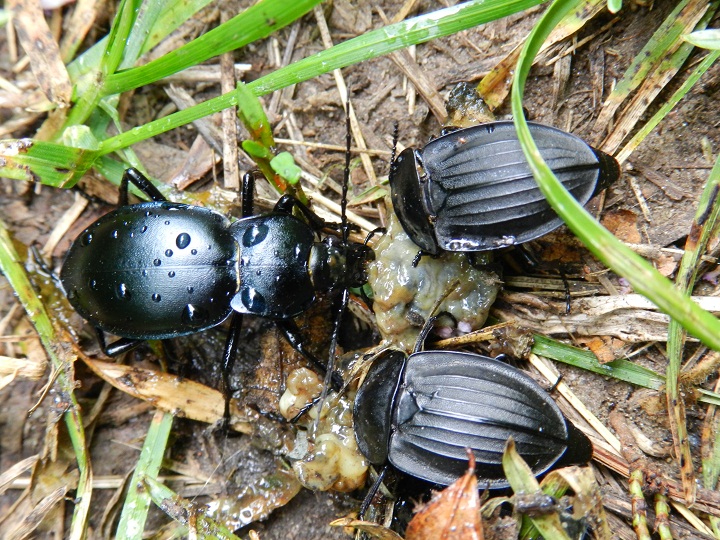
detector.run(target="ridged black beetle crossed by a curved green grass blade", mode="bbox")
[390,121,620,255]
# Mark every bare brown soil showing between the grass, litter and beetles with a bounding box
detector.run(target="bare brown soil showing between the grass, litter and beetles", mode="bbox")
[0,0,720,540]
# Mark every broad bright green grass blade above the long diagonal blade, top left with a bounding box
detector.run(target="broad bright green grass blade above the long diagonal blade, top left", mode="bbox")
[103,0,320,95]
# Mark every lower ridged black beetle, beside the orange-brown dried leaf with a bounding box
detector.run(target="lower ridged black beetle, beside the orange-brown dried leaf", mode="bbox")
[353,338,592,488]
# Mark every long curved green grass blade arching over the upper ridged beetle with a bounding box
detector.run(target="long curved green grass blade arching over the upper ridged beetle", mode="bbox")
[512,1,720,350]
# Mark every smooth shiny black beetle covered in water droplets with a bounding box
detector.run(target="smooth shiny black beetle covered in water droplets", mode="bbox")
[60,168,373,418]
